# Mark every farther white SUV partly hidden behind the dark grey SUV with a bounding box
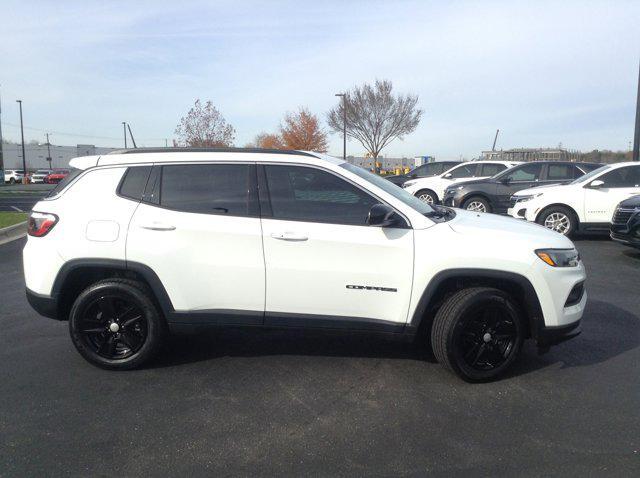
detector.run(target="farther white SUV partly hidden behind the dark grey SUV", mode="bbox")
[402,161,520,204]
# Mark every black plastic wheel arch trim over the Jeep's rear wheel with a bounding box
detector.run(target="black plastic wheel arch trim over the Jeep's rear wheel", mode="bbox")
[51,259,173,320]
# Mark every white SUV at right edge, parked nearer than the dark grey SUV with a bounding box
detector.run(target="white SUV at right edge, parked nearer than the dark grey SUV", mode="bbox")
[508,162,640,236]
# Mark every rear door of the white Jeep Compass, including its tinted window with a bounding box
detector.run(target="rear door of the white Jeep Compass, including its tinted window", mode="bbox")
[127,162,265,324]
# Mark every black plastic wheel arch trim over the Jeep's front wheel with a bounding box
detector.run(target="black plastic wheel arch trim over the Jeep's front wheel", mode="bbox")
[407,268,544,338]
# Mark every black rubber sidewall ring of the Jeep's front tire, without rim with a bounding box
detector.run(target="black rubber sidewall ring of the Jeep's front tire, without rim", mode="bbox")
[447,290,526,382]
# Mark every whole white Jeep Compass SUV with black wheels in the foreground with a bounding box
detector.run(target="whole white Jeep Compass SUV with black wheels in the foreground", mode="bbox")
[23,149,587,381]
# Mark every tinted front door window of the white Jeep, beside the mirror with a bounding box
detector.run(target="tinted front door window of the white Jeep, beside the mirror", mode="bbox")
[265,165,379,226]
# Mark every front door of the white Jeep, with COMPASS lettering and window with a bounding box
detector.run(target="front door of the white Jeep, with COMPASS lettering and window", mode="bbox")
[258,165,413,329]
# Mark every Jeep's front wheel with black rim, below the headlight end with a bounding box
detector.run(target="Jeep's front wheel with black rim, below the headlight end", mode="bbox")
[431,287,526,382]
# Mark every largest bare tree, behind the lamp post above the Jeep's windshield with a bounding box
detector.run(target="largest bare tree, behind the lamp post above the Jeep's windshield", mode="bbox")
[327,80,422,158]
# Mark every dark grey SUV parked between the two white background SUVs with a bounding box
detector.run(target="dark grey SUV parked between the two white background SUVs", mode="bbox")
[443,161,602,214]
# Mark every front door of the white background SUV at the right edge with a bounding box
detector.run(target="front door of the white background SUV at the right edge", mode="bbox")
[584,165,640,223]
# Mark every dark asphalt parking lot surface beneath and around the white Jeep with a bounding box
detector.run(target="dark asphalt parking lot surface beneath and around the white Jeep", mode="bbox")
[0,235,640,476]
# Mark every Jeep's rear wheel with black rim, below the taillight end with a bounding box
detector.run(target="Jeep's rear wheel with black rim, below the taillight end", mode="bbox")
[69,279,166,370]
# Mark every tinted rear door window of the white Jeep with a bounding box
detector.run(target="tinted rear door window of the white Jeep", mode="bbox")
[160,164,250,216]
